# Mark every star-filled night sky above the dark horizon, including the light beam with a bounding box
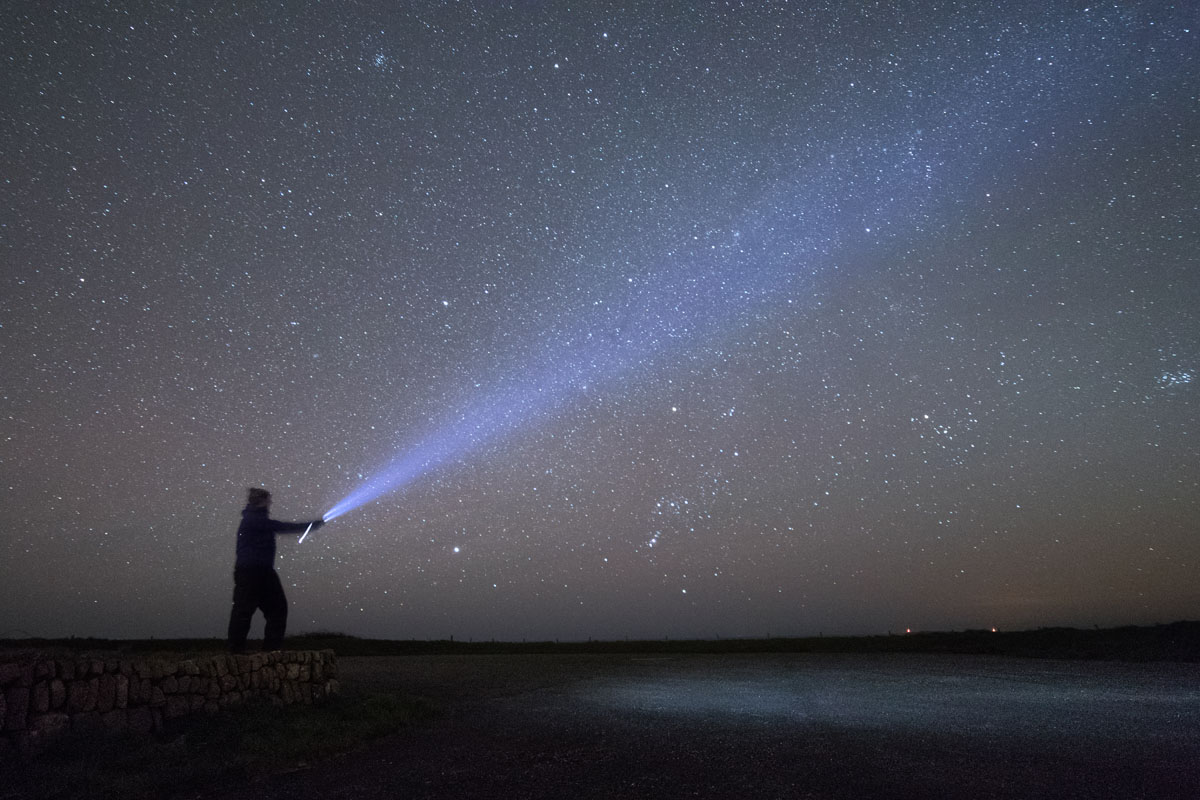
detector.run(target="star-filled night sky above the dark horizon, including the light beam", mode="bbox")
[0,0,1200,640]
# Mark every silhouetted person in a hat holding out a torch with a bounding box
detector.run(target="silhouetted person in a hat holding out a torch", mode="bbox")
[229,487,325,652]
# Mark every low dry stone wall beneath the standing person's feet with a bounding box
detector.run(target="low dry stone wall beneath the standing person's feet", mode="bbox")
[0,650,337,759]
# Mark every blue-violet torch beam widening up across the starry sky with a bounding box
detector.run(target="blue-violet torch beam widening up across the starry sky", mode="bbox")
[324,9,1174,521]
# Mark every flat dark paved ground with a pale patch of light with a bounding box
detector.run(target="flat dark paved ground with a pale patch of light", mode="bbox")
[192,654,1200,800]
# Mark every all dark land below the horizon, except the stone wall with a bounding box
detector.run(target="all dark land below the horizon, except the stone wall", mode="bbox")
[0,622,1200,800]
